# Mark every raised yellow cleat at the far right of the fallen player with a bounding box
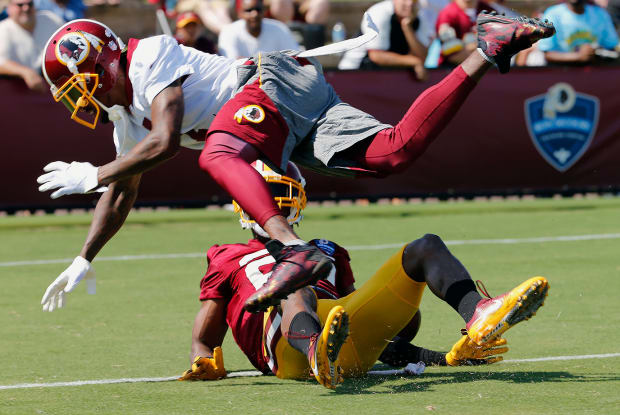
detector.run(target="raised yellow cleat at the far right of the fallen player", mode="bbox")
[466,277,549,345]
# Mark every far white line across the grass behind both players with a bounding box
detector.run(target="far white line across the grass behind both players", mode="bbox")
[0,233,620,267]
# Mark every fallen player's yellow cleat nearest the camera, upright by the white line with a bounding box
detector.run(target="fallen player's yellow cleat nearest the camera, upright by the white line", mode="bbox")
[308,305,349,389]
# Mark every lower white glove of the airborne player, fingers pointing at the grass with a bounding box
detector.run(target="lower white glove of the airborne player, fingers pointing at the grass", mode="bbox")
[41,256,96,312]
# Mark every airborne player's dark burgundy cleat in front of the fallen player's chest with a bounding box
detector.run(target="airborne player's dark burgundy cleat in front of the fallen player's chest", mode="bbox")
[244,239,333,313]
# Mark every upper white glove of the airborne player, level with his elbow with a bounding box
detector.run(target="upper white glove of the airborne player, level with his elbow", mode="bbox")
[37,161,107,199]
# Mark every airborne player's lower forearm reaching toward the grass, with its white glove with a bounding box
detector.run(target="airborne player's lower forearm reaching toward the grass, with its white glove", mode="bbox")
[41,175,140,311]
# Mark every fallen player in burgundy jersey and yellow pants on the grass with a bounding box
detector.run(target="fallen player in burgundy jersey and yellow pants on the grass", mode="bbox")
[180,161,548,388]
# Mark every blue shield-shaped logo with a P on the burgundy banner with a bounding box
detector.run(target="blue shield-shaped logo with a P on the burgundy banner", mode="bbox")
[525,82,599,172]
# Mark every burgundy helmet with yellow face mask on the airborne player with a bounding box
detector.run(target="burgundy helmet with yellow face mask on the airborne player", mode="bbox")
[42,19,125,128]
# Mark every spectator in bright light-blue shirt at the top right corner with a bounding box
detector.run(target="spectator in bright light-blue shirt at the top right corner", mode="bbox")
[538,0,618,63]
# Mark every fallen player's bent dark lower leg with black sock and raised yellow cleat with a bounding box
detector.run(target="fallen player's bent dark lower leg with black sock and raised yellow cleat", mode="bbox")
[403,235,548,344]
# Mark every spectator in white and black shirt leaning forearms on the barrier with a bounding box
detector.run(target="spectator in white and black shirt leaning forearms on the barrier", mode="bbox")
[338,0,435,80]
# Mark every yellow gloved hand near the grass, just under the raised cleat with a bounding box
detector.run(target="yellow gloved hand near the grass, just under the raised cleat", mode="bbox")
[446,335,508,366]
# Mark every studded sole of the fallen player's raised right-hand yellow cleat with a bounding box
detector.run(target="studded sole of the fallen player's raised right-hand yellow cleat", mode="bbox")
[468,277,549,345]
